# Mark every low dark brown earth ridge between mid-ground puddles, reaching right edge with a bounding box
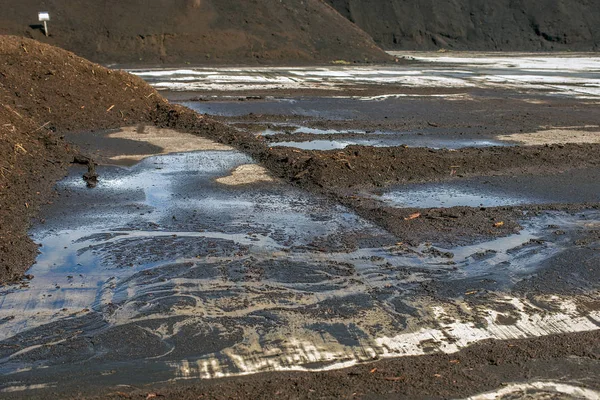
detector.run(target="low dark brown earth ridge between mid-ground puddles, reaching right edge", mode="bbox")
[269,144,600,189]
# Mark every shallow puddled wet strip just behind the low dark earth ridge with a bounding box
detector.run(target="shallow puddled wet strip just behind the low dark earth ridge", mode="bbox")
[181,94,600,150]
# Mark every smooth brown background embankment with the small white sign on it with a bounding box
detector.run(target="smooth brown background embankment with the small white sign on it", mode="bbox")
[0,0,390,64]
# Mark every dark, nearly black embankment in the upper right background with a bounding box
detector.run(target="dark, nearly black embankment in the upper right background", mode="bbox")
[326,0,600,51]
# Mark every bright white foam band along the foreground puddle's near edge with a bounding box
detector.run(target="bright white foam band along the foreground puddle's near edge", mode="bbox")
[169,296,600,380]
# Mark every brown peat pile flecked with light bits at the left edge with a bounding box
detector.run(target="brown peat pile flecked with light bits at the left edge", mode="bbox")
[0,36,167,282]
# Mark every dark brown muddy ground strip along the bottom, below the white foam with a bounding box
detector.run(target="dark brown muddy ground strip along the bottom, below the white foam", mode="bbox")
[6,332,600,399]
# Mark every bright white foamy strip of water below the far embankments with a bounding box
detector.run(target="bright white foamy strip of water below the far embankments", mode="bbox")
[130,52,600,99]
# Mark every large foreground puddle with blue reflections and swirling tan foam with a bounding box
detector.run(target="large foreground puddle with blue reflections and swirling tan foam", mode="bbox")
[0,151,600,390]
